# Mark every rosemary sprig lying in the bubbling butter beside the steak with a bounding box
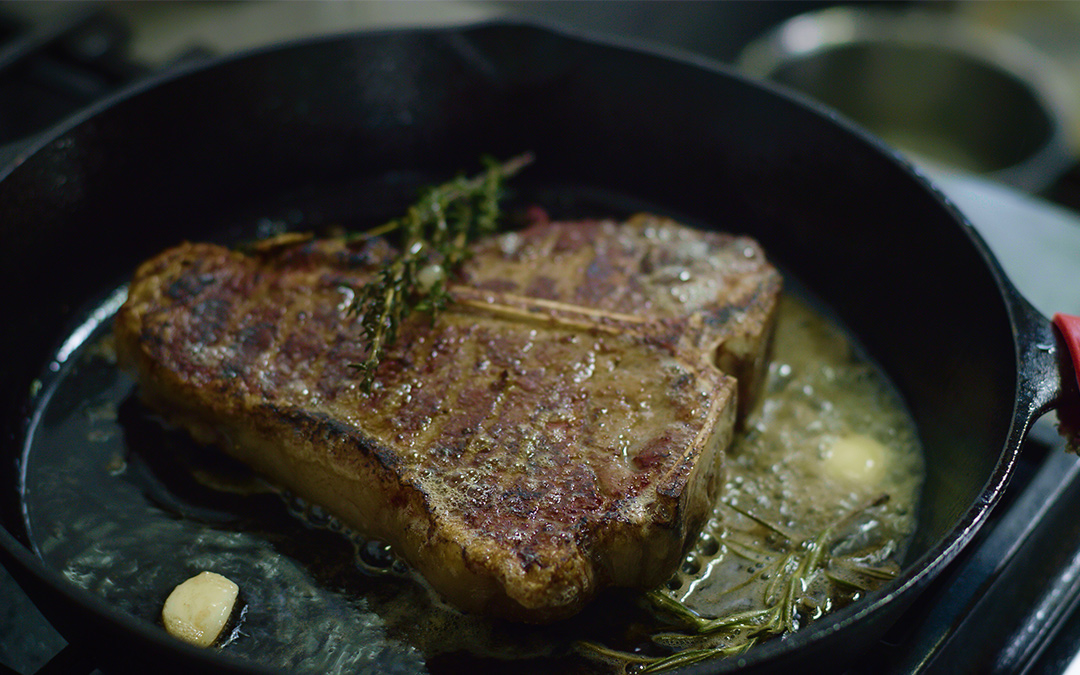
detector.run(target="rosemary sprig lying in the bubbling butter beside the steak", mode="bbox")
[578,496,897,674]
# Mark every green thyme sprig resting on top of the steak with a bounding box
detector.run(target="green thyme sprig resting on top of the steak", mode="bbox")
[347,153,532,391]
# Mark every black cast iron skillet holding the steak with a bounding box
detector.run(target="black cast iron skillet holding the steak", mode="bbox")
[0,18,1075,672]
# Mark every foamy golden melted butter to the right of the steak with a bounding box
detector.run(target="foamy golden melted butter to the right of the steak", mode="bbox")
[665,296,923,649]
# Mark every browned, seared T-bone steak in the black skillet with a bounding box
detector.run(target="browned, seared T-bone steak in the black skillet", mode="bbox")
[116,211,780,622]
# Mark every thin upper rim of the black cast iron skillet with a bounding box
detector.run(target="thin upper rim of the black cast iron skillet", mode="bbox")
[0,17,1041,673]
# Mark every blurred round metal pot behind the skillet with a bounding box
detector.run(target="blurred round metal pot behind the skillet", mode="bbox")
[737,8,1077,193]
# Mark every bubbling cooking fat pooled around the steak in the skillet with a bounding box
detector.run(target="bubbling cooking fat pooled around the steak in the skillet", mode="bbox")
[23,292,922,673]
